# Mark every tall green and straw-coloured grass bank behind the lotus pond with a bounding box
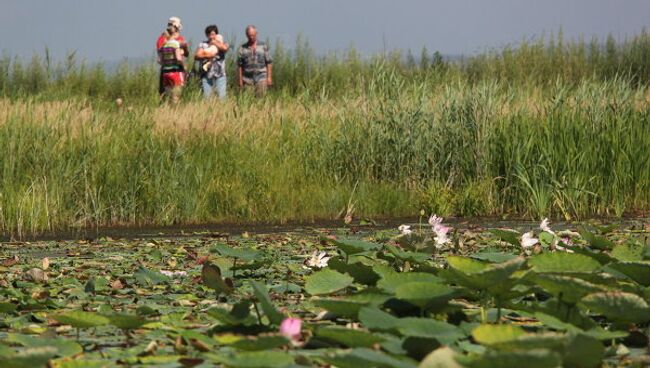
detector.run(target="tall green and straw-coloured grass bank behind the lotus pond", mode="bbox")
[0,35,650,235]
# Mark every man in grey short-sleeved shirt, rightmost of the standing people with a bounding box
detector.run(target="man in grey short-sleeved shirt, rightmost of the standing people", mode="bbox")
[237,26,273,96]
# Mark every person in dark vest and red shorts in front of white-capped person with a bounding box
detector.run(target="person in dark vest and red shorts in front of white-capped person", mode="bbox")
[158,24,185,104]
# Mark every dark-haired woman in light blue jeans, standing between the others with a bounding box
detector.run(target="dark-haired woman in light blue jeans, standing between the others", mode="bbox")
[194,24,230,100]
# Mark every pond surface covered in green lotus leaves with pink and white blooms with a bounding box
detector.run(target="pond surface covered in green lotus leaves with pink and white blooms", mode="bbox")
[0,220,650,368]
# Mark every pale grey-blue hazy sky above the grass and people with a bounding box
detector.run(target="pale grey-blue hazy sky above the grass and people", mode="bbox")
[0,0,650,61]
